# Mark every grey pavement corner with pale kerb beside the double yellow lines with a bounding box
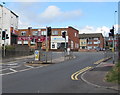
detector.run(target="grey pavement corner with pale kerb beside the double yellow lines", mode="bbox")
[81,62,120,92]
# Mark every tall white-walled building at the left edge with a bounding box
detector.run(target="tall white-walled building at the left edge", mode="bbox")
[0,5,18,46]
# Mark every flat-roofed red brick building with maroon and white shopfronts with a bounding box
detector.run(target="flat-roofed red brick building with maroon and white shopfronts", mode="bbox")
[17,27,79,50]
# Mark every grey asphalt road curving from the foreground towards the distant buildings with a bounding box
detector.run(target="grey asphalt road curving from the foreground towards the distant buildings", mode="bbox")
[2,52,117,93]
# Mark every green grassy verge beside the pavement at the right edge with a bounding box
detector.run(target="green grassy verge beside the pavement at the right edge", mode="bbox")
[105,60,120,84]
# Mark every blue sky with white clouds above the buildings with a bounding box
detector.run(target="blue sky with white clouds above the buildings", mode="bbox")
[0,0,118,36]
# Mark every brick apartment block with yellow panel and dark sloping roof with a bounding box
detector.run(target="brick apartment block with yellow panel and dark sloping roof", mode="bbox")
[79,33,104,51]
